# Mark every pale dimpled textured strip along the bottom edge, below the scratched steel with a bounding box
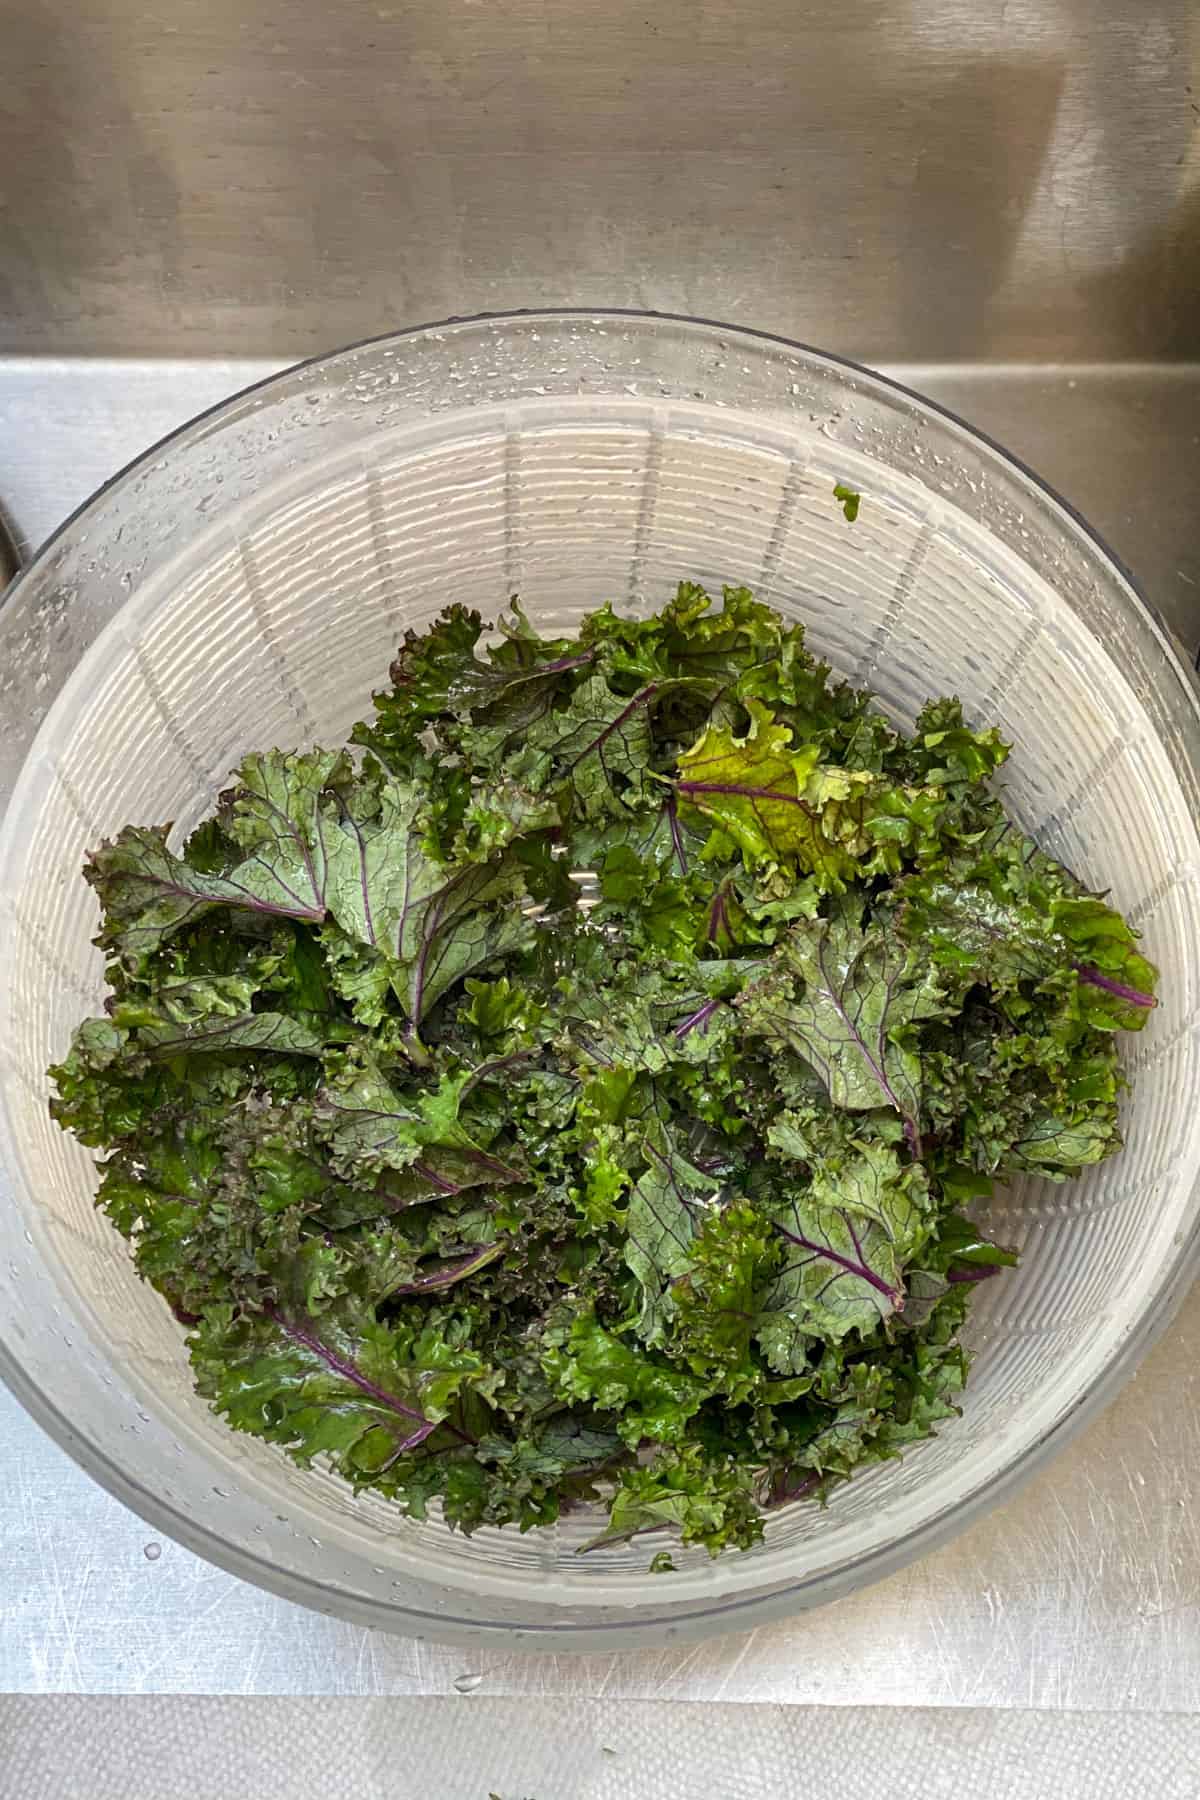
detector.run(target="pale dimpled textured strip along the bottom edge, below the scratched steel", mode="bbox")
[0,1696,1200,1800]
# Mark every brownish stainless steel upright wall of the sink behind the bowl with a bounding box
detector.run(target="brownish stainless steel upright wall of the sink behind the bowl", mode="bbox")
[0,0,1200,362]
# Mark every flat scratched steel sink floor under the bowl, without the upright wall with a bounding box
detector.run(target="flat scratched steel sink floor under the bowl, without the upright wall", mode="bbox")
[0,362,1200,1712]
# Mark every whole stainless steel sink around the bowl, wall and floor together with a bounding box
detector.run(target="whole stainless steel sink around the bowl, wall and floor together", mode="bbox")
[0,0,1200,1713]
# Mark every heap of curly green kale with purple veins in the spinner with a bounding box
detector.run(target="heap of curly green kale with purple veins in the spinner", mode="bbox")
[50,586,1157,1570]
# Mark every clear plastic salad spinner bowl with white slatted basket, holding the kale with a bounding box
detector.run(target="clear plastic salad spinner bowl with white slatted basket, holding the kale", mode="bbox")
[0,313,1200,1651]
